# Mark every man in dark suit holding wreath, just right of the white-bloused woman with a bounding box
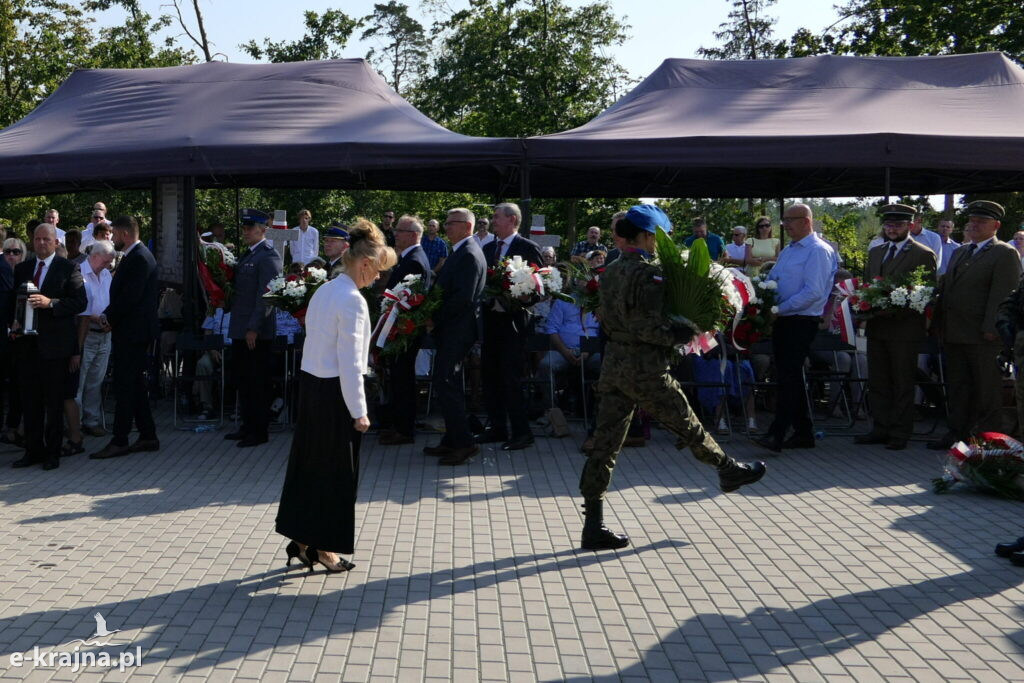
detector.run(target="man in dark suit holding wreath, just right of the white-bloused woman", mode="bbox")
[380,216,434,445]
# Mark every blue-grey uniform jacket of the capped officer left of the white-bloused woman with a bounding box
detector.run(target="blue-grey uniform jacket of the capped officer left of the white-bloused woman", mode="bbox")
[228,242,282,340]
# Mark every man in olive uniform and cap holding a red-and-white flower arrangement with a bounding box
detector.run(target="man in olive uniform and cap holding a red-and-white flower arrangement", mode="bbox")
[853,204,936,451]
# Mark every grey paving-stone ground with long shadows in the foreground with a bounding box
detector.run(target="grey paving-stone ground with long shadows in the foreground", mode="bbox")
[0,413,1024,682]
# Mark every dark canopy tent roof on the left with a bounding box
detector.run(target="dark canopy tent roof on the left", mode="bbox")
[0,59,522,197]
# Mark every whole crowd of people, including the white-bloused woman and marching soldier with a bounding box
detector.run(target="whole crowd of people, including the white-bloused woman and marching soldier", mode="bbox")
[8,194,1024,570]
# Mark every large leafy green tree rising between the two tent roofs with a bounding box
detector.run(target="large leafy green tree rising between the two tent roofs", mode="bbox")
[412,0,628,137]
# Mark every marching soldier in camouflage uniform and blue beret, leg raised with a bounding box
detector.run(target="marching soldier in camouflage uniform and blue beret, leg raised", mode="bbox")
[580,205,765,550]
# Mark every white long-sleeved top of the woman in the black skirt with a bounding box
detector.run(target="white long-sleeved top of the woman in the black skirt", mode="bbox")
[302,273,371,419]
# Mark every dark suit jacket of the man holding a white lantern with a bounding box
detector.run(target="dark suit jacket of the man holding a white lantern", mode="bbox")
[14,250,87,359]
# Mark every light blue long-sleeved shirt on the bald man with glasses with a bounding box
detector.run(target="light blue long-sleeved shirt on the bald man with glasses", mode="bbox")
[768,232,839,316]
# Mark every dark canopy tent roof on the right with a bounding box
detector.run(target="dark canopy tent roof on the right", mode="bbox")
[526,52,1024,197]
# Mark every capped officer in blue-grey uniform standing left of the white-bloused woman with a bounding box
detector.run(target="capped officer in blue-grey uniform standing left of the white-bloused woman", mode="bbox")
[224,209,282,449]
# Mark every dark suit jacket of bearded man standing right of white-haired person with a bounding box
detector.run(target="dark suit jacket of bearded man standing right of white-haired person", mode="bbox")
[103,242,160,344]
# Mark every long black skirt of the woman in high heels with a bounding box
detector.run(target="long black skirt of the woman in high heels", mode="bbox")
[276,373,361,555]
